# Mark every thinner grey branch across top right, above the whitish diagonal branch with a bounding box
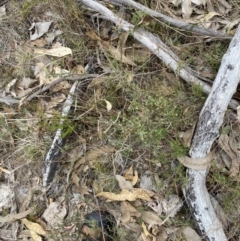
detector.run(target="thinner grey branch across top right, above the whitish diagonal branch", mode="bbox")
[108,0,232,39]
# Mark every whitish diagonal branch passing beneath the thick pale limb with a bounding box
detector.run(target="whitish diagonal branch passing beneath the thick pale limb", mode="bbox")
[79,0,239,109]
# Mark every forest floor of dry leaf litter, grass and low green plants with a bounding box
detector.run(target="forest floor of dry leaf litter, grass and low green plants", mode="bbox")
[0,0,240,241]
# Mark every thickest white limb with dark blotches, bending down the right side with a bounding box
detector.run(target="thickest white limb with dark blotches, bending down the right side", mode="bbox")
[184,26,240,241]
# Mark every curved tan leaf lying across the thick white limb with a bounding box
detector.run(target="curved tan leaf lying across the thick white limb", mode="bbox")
[177,152,214,170]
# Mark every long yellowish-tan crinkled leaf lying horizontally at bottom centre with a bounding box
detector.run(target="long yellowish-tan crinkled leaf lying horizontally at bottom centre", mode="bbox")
[97,189,151,202]
